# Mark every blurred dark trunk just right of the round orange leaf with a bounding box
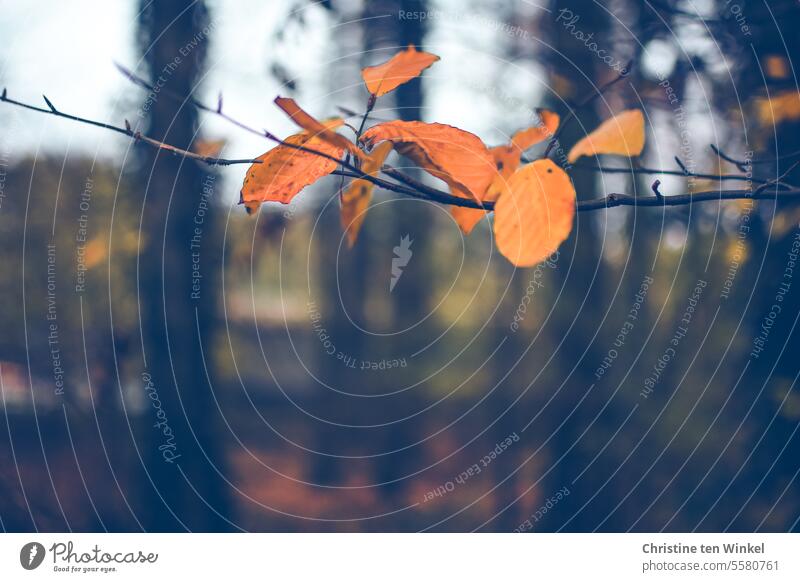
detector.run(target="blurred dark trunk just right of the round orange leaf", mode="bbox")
[537,0,617,531]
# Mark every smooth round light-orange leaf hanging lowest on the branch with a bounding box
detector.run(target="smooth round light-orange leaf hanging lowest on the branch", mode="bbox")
[494,159,575,267]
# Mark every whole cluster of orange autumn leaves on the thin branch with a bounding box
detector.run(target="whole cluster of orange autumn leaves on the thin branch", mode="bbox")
[241,46,645,267]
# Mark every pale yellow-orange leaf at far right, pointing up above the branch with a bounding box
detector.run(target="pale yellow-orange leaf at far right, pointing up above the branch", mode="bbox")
[567,109,644,163]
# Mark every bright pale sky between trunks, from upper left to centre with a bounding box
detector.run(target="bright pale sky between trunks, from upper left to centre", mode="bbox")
[0,0,564,203]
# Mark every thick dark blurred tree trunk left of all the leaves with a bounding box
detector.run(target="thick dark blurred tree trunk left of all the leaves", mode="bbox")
[138,0,230,531]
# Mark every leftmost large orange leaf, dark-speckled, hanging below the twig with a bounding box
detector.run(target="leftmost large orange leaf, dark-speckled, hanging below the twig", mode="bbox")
[239,119,344,214]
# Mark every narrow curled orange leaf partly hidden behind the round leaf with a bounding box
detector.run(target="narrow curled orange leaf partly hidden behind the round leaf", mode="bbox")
[450,110,560,234]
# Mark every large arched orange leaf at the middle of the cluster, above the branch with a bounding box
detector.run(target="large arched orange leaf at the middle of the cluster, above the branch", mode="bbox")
[361,121,495,200]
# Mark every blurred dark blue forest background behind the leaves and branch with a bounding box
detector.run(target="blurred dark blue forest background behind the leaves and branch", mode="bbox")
[0,0,800,531]
